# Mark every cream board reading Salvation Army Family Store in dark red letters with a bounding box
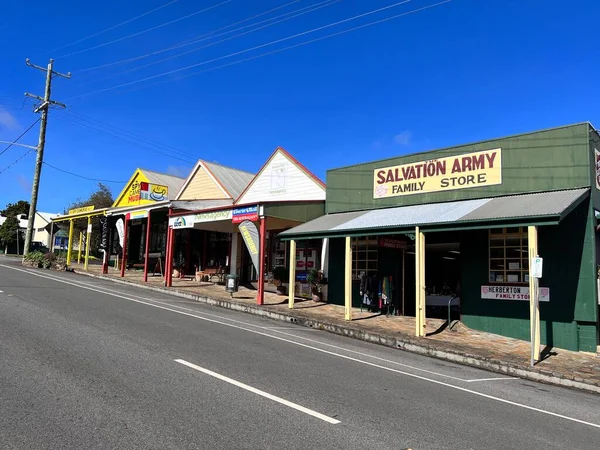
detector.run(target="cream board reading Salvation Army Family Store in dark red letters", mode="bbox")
[373,148,502,199]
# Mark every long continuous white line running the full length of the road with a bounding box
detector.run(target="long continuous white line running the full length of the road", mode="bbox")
[0,264,600,429]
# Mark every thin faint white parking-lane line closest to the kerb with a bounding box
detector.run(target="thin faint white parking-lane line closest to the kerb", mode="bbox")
[12,271,488,383]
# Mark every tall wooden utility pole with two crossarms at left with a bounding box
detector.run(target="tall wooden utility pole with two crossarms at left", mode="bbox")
[23,58,71,256]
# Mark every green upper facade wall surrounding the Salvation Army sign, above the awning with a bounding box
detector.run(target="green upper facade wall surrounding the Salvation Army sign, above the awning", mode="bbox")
[327,124,600,213]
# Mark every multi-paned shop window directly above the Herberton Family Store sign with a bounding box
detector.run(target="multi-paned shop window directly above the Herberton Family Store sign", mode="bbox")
[489,227,529,284]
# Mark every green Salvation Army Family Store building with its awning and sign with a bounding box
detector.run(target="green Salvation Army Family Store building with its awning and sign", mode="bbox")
[281,123,600,352]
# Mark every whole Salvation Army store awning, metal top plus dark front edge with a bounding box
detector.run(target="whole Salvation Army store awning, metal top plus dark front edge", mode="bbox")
[279,188,589,240]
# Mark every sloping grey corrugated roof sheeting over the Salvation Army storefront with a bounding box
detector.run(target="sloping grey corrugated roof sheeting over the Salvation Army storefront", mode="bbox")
[280,188,589,237]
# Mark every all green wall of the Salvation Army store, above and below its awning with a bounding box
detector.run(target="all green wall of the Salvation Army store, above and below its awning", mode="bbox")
[326,124,600,352]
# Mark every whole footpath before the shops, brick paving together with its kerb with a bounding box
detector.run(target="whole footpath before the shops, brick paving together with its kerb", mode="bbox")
[73,265,600,394]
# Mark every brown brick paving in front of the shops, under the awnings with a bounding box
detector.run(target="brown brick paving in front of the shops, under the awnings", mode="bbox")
[74,264,600,388]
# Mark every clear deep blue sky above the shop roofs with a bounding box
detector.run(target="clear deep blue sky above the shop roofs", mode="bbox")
[0,0,600,212]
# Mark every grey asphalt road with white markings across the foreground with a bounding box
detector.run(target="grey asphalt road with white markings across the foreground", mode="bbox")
[0,258,600,450]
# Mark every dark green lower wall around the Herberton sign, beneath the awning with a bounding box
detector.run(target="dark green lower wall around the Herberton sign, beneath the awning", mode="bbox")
[461,201,597,352]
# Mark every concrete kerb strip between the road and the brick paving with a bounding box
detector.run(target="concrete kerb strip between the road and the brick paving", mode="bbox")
[76,272,600,394]
